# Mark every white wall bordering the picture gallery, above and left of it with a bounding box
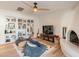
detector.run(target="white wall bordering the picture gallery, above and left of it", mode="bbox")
[0,9,39,43]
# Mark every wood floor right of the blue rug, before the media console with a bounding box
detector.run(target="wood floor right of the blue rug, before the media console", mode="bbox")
[38,39,65,57]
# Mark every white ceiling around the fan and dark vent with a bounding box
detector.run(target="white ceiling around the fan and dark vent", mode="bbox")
[0,1,79,14]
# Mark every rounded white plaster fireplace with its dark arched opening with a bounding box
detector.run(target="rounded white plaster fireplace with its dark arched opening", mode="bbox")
[60,28,79,57]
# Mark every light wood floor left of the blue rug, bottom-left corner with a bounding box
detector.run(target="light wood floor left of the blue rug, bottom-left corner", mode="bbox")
[0,43,19,57]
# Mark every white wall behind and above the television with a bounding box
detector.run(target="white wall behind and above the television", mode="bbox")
[40,11,63,35]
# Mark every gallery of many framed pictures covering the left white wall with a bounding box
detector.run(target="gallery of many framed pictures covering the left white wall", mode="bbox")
[5,17,34,42]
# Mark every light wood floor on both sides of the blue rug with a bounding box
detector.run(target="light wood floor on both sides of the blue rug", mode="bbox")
[0,39,65,57]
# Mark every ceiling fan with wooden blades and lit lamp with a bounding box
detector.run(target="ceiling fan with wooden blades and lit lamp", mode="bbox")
[23,2,49,12]
